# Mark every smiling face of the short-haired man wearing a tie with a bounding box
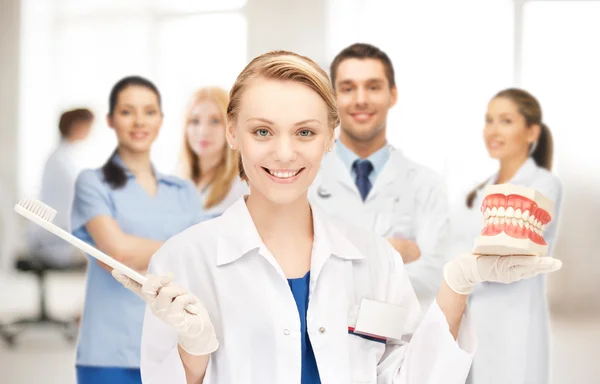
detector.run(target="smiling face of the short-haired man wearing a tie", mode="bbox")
[335,58,397,143]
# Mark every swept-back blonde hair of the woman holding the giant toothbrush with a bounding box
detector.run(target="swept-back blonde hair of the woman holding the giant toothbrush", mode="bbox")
[227,51,340,181]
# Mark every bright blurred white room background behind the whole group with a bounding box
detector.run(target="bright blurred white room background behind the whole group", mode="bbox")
[0,0,600,384]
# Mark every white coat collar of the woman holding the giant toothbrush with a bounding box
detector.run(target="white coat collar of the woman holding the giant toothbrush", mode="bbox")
[217,197,364,268]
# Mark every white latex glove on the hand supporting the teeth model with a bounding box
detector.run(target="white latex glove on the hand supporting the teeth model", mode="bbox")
[444,254,562,295]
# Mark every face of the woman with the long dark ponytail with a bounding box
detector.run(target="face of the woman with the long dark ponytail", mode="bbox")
[483,97,540,161]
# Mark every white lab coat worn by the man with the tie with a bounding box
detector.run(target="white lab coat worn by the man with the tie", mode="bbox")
[309,146,449,310]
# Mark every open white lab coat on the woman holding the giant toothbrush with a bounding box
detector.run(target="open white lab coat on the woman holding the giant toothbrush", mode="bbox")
[141,198,476,384]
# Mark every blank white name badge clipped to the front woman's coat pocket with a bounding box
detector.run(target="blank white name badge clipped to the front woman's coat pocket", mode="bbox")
[348,298,408,342]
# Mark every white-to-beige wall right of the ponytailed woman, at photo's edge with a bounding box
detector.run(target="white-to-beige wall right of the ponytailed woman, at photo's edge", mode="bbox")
[522,1,600,313]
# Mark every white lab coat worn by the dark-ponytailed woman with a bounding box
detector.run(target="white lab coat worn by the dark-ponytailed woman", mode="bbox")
[451,159,562,384]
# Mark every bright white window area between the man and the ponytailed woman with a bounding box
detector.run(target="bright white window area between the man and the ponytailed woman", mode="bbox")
[327,0,513,204]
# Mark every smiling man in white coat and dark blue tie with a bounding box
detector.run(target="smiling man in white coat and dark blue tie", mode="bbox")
[310,44,449,307]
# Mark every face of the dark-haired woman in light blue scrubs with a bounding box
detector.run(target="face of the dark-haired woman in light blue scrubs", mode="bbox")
[107,85,163,153]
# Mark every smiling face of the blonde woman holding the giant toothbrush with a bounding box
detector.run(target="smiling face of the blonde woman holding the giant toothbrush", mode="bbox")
[228,77,334,204]
